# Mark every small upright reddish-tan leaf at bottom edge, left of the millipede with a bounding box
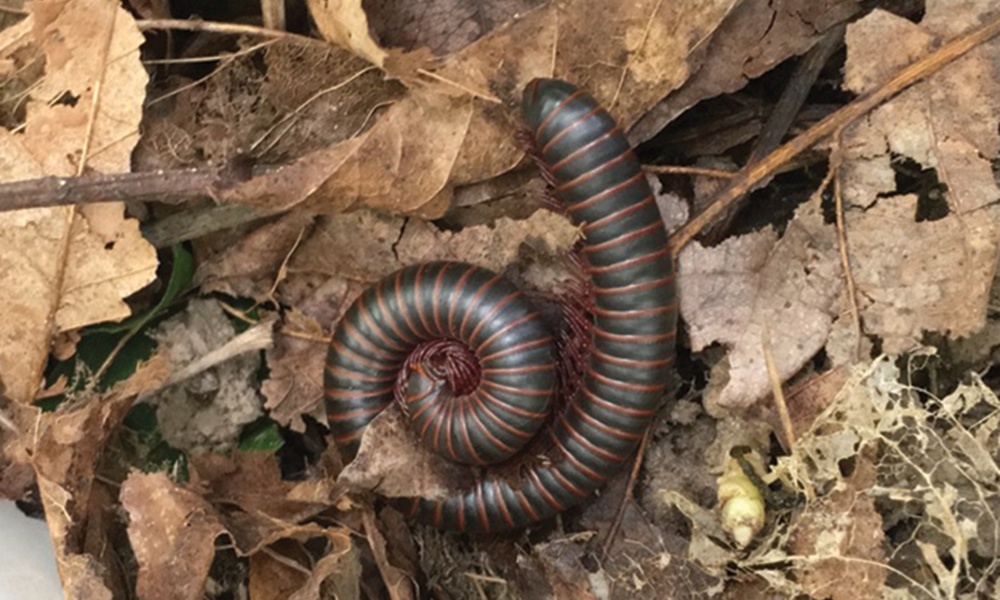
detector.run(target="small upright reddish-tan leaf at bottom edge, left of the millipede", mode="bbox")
[121,472,225,600]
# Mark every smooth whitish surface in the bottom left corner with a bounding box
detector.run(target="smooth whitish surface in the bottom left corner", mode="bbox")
[0,500,63,600]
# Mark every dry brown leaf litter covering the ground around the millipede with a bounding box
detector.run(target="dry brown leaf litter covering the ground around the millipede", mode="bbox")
[0,0,1000,599]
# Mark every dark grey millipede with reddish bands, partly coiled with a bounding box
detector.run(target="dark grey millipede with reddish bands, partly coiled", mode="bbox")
[324,79,677,531]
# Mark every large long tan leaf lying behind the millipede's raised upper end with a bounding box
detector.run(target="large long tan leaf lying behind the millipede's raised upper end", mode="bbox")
[227,0,735,217]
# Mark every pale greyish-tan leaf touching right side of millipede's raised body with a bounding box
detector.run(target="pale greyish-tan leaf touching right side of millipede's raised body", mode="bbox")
[678,198,843,415]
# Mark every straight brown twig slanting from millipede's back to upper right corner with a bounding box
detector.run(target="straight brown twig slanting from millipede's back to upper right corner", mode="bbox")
[671,16,1000,256]
